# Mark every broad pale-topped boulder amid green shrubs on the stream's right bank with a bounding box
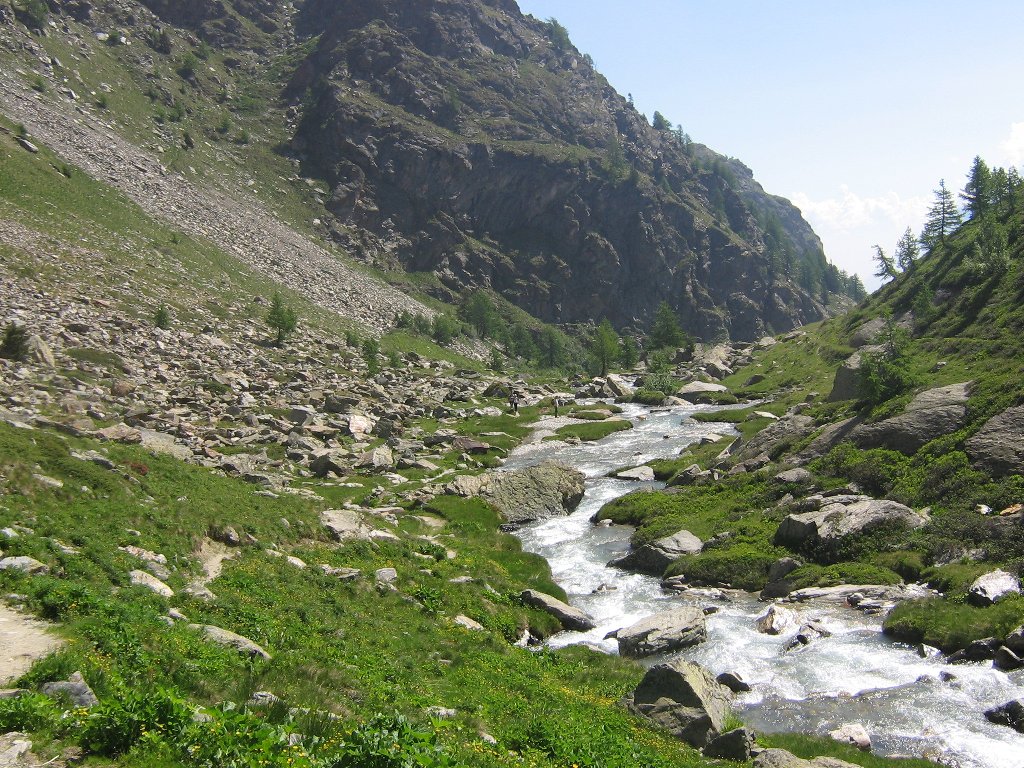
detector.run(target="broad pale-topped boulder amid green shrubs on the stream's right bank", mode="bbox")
[775,497,928,559]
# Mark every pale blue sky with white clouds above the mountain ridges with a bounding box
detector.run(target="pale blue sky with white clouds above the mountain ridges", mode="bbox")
[519,0,1024,289]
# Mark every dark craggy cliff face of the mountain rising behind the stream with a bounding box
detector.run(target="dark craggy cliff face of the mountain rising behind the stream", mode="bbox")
[290,0,850,339]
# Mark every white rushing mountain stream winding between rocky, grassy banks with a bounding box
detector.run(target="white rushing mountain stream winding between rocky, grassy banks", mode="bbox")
[506,406,1024,768]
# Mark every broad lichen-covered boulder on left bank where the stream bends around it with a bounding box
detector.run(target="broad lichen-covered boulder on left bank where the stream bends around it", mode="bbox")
[480,462,586,522]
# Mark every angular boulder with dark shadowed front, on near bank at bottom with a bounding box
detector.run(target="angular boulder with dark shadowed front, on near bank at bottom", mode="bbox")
[627,659,732,746]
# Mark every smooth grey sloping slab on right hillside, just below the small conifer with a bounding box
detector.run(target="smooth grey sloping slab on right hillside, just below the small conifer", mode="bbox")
[850,382,971,456]
